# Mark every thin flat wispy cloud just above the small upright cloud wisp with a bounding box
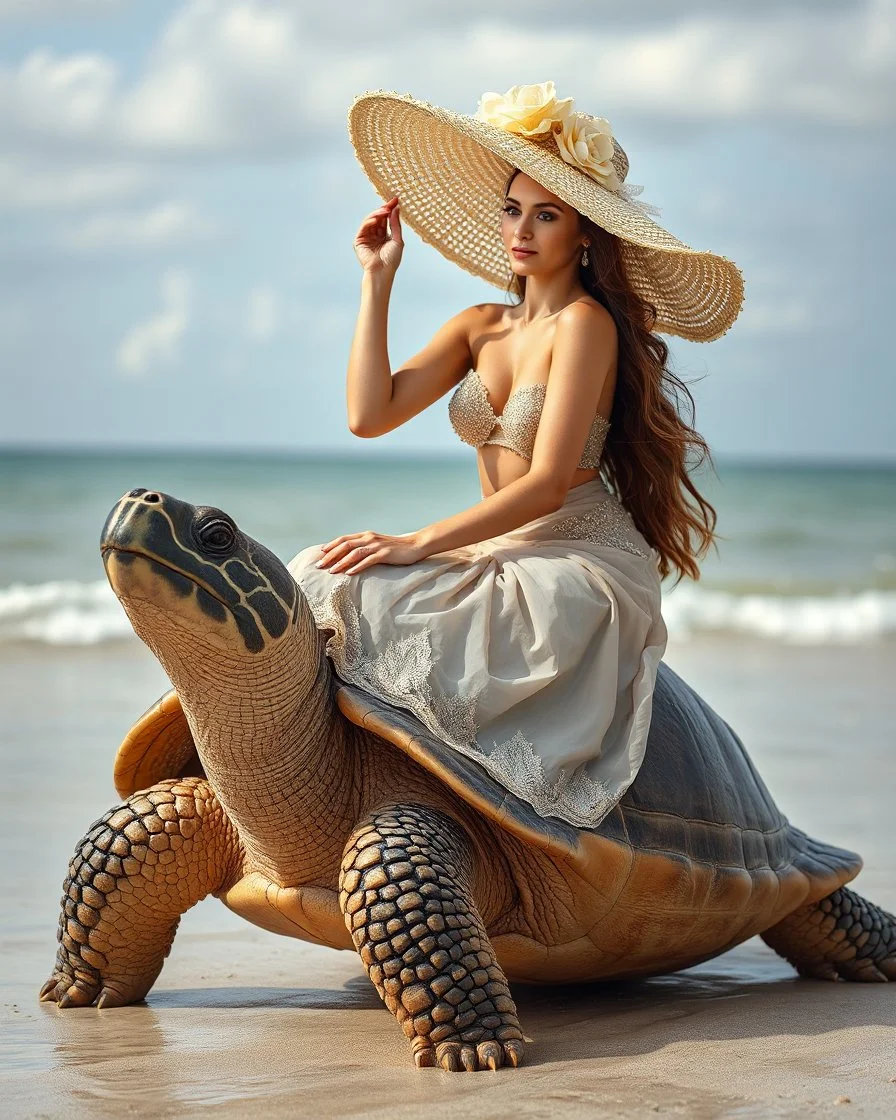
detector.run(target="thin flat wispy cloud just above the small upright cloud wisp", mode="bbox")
[60,202,215,252]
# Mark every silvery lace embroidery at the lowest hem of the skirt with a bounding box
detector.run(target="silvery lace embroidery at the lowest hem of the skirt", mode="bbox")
[487,731,617,828]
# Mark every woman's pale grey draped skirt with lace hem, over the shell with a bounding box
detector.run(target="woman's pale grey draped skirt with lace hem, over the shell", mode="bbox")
[289,478,668,828]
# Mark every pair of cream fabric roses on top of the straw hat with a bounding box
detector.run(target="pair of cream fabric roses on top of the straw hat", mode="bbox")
[474,82,622,193]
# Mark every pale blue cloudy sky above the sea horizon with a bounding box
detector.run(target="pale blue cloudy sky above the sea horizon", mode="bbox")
[0,0,896,461]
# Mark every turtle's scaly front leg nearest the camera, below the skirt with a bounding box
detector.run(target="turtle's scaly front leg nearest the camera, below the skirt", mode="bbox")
[339,805,523,1071]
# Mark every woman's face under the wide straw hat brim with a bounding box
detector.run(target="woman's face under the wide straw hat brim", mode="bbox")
[501,171,587,277]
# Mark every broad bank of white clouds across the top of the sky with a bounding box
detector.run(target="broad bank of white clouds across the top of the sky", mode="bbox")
[0,0,896,158]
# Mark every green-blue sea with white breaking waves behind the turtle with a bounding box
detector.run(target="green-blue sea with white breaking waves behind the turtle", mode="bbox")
[0,451,896,651]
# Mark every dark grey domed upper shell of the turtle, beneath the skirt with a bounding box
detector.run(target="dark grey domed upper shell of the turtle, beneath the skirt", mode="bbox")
[336,662,861,902]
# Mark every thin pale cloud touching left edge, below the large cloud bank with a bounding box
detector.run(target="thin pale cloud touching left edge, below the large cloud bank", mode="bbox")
[0,157,149,209]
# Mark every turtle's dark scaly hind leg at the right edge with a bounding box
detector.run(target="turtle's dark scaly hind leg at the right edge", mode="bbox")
[762,887,896,981]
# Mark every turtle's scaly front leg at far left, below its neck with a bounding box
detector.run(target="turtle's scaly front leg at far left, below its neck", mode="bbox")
[40,777,239,1007]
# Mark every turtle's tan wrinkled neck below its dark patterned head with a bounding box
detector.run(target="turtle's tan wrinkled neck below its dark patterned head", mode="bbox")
[150,601,355,886]
